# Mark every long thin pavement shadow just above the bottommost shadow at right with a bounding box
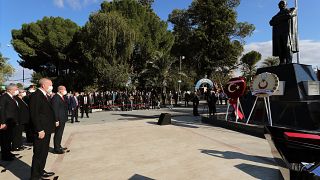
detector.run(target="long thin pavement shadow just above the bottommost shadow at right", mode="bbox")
[199,149,277,166]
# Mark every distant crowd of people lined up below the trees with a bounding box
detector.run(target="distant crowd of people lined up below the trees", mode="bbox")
[62,90,227,112]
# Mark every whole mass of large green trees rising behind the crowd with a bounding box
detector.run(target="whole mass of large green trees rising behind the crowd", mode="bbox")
[12,0,254,91]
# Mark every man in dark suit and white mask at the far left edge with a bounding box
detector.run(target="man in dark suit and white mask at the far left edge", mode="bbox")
[0,84,19,161]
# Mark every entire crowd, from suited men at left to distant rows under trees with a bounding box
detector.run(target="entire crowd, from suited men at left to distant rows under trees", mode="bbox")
[0,78,226,179]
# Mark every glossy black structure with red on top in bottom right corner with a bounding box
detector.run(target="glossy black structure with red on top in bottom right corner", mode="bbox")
[265,126,320,180]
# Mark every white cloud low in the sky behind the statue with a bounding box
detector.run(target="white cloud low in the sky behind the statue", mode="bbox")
[244,40,320,67]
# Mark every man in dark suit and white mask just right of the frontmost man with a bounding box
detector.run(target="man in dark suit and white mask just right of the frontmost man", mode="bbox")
[51,86,68,154]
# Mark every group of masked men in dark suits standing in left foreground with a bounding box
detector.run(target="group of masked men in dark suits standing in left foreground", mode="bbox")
[0,78,69,180]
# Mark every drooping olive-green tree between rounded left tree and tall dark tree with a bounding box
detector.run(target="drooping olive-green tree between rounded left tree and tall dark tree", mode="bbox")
[79,12,135,89]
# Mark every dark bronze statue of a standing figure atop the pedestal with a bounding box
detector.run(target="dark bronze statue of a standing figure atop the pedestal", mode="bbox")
[270,0,299,64]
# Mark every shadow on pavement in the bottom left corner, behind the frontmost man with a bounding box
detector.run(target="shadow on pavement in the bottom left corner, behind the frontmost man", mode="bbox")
[0,156,31,180]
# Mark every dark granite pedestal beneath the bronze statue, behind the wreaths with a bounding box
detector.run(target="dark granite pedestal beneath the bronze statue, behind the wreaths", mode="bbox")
[252,64,320,131]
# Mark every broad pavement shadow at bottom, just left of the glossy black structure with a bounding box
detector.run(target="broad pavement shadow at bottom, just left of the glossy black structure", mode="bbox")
[235,163,283,180]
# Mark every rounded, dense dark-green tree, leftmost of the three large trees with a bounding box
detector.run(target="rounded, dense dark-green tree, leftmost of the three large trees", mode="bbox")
[12,17,79,88]
